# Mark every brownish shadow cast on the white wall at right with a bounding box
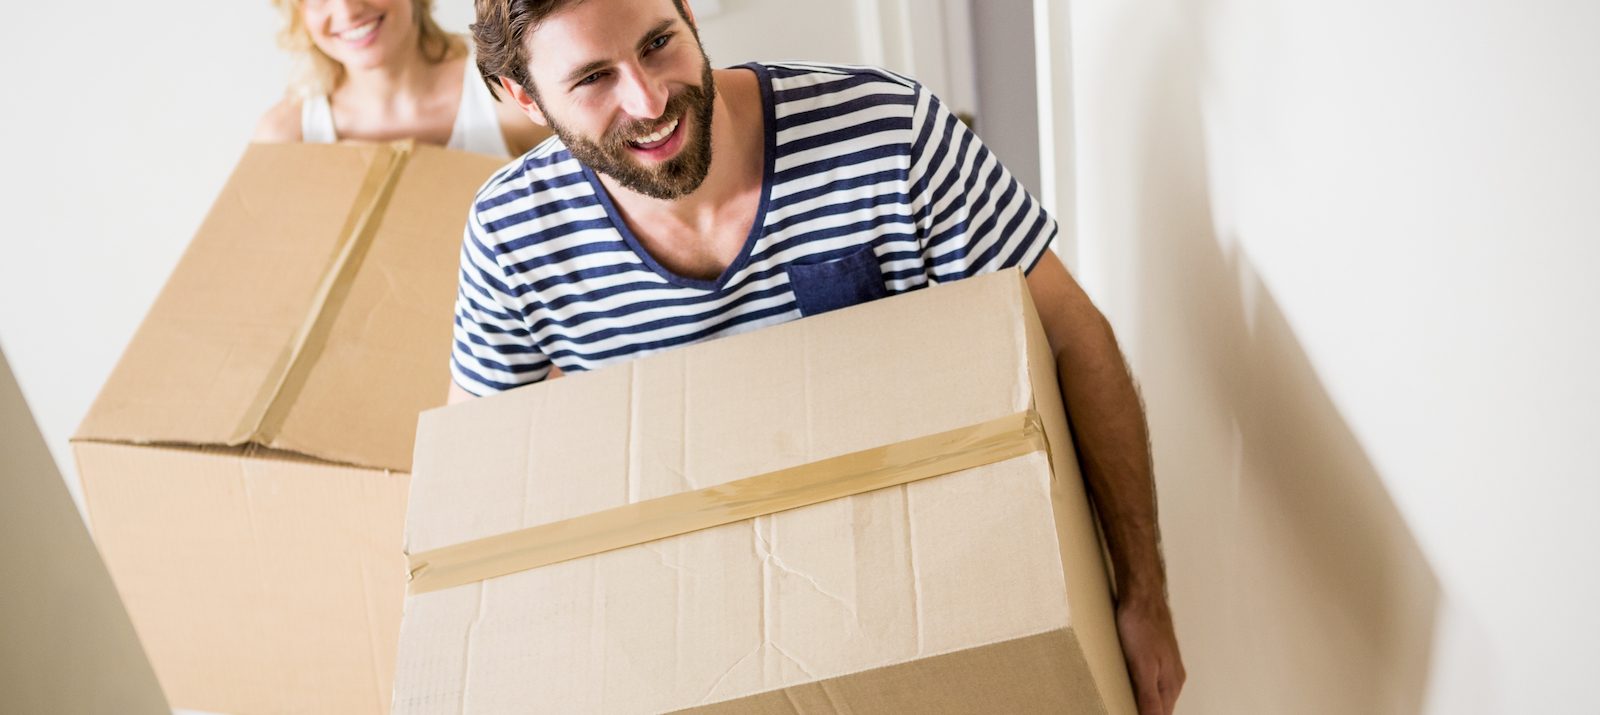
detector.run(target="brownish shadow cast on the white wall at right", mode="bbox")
[1080,6,1442,715]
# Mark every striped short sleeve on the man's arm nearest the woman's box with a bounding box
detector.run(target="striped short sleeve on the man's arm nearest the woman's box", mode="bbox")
[450,216,550,397]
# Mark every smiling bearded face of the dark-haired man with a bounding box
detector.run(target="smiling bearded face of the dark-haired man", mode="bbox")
[528,0,717,200]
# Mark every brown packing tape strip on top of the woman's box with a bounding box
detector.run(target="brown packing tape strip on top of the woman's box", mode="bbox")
[229,139,416,445]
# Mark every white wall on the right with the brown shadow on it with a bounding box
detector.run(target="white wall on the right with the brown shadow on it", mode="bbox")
[1074,0,1600,715]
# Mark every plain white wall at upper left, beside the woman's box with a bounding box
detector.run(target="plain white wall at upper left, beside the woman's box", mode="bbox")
[0,0,288,515]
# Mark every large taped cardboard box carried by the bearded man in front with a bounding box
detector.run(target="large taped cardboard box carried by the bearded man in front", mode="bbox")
[395,272,1134,713]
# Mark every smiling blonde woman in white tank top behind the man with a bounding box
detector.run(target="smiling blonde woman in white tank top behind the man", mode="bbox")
[254,0,549,157]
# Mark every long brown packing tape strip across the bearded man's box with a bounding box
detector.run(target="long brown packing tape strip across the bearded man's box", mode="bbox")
[410,409,1050,593]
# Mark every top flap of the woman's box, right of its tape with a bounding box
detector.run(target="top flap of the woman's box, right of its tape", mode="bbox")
[267,147,504,472]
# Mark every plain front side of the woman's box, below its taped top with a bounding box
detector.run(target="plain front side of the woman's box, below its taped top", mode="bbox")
[74,443,408,713]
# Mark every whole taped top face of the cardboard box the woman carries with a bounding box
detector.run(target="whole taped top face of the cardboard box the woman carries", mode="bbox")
[75,144,499,470]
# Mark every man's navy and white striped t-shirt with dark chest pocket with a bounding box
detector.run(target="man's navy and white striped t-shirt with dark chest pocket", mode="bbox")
[451,62,1056,395]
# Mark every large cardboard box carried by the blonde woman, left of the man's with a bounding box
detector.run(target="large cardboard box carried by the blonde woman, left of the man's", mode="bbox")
[74,144,499,713]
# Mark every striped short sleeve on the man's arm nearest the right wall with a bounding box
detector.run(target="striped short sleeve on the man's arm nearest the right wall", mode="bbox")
[909,85,1059,283]
